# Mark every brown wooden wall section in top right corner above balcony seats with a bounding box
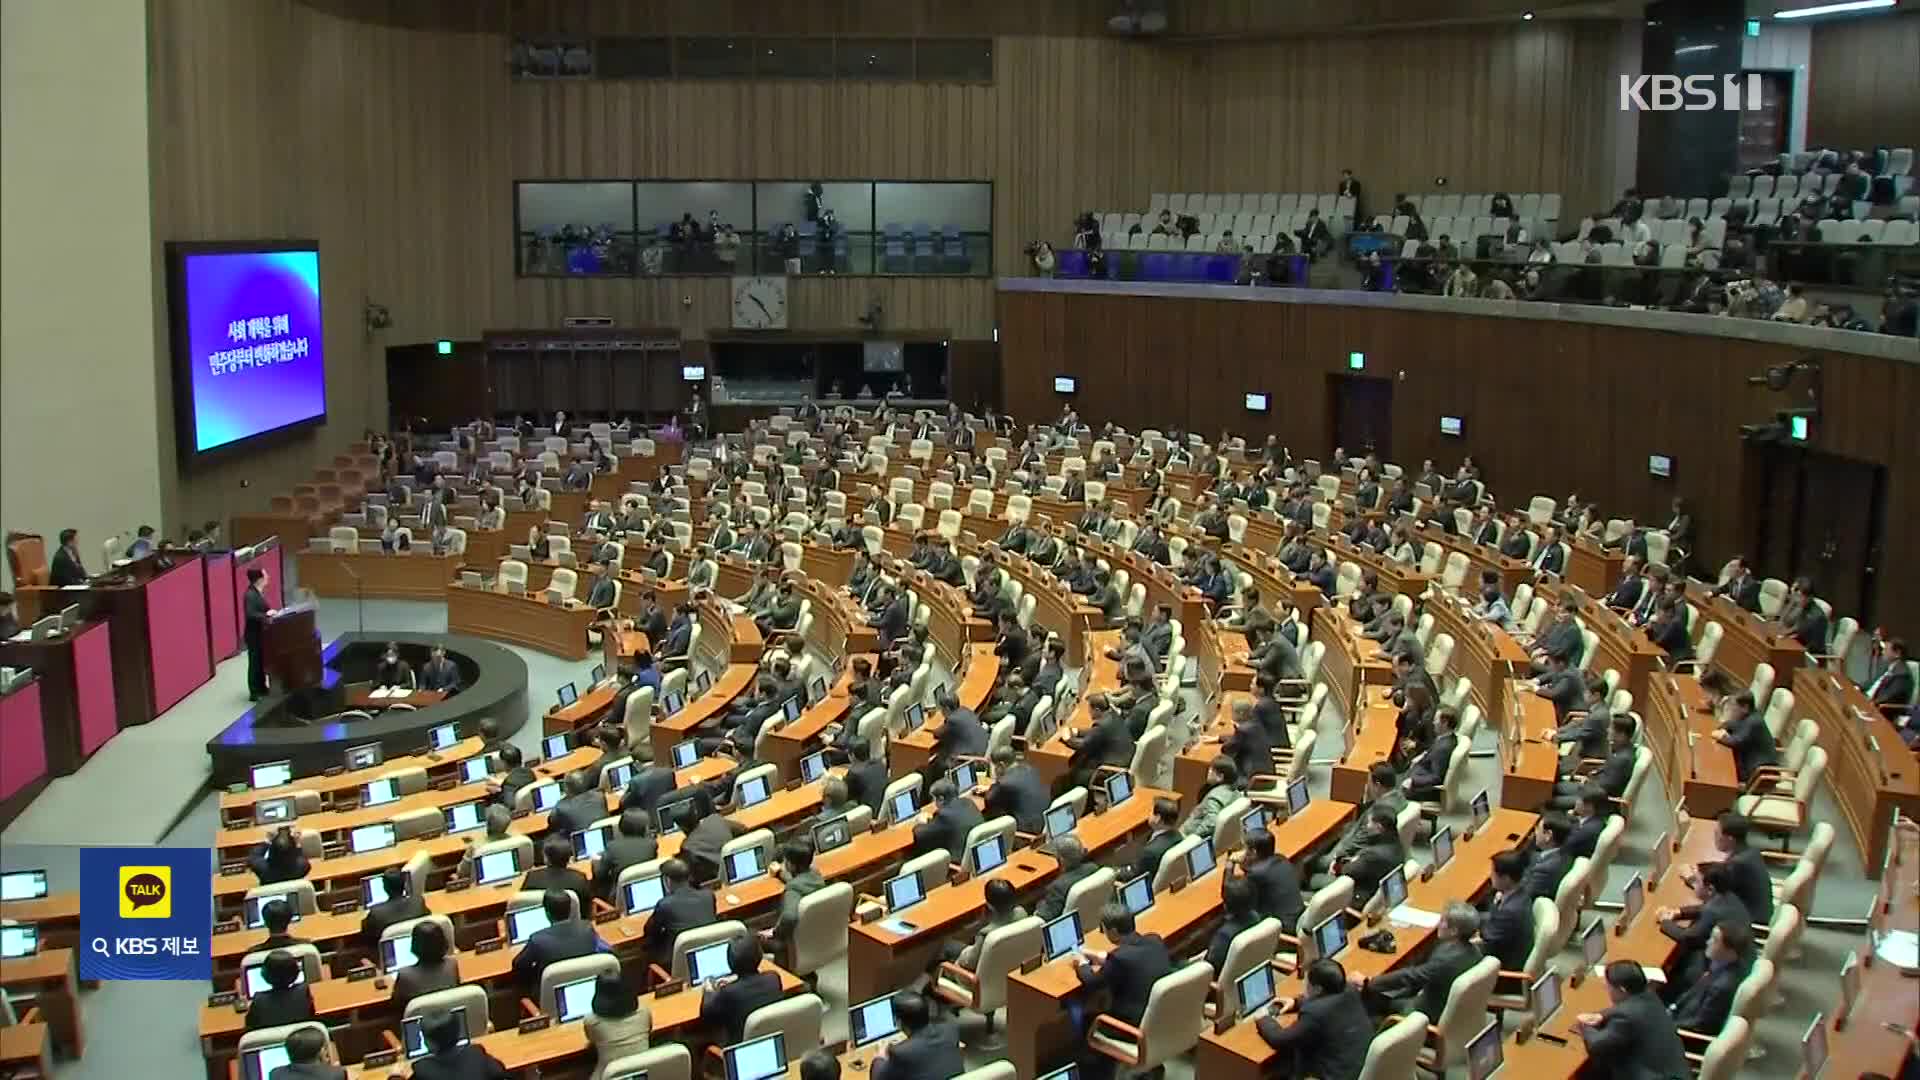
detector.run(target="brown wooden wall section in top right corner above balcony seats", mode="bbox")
[1807,10,1920,150]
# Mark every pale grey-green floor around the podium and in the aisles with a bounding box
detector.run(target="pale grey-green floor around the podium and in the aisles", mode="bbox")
[0,600,1874,1080]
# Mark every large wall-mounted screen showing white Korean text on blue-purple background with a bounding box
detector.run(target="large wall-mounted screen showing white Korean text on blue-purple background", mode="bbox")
[167,240,326,463]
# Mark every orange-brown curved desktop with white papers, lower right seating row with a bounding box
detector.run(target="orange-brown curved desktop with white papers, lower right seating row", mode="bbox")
[1194,807,1538,1080]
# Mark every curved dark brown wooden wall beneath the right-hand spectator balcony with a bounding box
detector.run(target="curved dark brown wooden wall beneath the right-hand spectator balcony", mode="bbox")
[1000,292,1920,634]
